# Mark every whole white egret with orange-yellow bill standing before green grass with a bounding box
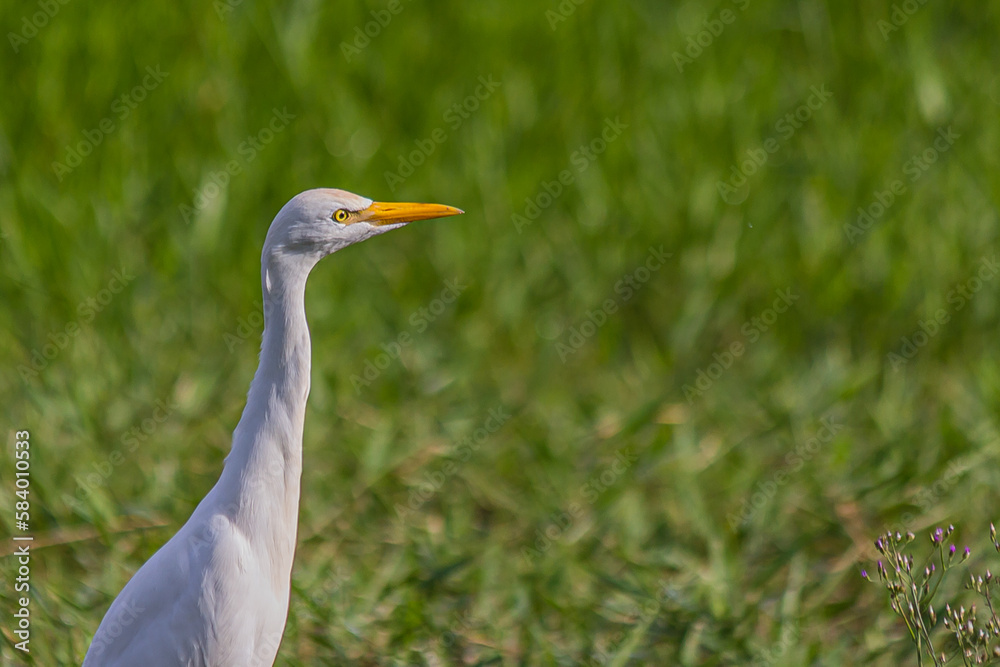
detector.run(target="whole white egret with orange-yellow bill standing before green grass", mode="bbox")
[83,189,462,667]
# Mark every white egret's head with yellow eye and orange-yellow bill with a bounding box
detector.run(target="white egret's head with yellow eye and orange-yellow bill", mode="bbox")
[263,188,463,264]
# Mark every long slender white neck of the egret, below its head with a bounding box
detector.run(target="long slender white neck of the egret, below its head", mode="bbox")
[217,256,312,590]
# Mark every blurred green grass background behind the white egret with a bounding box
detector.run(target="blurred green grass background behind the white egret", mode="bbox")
[0,0,1000,665]
